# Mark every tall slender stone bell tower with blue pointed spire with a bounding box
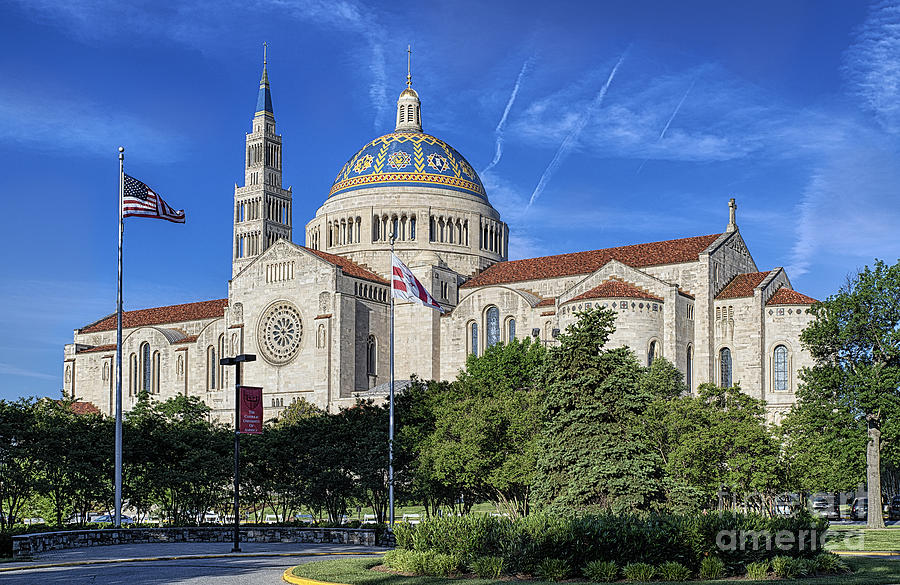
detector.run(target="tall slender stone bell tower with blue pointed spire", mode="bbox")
[231,43,292,278]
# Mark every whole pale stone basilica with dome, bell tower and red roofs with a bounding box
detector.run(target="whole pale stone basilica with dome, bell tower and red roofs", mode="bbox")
[63,61,815,422]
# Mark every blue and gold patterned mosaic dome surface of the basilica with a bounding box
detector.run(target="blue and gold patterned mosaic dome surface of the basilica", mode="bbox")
[328,132,487,200]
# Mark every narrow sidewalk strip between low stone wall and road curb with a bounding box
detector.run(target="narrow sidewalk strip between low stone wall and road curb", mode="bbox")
[0,542,388,574]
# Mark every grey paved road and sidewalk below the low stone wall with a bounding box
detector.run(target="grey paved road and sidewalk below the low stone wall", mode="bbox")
[0,543,384,585]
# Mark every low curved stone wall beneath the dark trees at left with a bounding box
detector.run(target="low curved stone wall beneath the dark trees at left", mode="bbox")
[12,526,375,559]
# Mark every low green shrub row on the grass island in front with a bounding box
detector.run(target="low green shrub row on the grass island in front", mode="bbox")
[394,512,828,574]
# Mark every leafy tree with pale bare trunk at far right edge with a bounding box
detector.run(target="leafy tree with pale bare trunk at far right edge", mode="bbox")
[800,260,900,528]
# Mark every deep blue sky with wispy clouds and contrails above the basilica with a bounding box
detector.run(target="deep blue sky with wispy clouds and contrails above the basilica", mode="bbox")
[0,0,900,399]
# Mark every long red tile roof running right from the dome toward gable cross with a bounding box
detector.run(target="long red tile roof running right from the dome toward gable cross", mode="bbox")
[462,234,720,288]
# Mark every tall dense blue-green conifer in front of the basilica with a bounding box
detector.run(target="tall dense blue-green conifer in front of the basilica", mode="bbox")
[535,308,662,511]
